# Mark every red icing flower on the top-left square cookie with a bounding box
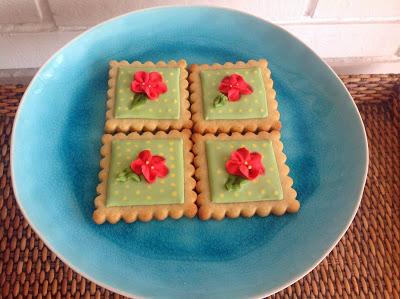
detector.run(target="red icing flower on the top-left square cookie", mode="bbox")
[131,71,167,100]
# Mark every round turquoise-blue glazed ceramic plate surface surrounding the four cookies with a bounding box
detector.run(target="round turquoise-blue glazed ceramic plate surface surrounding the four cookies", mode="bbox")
[11,7,368,298]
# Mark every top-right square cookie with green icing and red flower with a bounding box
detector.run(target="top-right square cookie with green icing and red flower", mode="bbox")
[189,59,281,133]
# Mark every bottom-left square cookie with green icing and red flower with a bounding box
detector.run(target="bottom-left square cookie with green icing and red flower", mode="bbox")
[93,130,197,224]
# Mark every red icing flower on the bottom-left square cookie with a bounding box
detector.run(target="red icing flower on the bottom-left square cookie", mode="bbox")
[131,150,169,184]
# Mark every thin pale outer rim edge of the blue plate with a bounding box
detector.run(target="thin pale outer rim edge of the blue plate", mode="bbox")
[10,5,369,298]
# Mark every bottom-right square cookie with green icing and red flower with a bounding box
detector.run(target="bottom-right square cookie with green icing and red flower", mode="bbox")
[193,131,300,220]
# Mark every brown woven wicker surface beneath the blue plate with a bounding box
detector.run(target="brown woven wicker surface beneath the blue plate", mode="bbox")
[0,75,400,298]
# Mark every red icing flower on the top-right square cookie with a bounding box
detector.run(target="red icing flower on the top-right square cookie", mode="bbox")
[219,74,253,102]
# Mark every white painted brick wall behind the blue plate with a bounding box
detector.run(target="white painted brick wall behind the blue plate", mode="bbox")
[0,0,400,82]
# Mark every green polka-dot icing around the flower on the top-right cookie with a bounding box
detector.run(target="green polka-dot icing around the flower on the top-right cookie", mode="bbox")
[200,67,268,120]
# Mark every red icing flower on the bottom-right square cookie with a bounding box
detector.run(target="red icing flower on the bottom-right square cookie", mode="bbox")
[225,147,265,180]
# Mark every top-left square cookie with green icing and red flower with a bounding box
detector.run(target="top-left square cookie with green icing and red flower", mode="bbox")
[105,60,192,133]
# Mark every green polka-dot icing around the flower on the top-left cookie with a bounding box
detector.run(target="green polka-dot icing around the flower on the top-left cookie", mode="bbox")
[114,66,180,120]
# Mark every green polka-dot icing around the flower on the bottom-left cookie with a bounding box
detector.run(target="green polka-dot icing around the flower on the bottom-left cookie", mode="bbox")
[106,139,184,207]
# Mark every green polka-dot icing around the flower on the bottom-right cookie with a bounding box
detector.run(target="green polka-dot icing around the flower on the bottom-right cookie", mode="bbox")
[206,140,283,203]
